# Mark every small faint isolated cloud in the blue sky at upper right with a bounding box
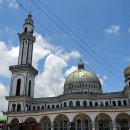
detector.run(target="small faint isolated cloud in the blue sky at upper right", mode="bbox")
[105,25,120,34]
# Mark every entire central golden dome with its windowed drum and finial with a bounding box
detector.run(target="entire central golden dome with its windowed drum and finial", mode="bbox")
[64,61,102,93]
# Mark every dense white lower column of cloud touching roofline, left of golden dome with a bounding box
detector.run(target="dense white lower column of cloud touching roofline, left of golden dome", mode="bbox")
[35,54,67,97]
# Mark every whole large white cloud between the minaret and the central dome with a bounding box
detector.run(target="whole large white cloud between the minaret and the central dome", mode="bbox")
[34,35,80,97]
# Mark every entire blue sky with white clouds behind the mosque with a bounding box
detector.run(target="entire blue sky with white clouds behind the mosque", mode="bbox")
[0,0,130,109]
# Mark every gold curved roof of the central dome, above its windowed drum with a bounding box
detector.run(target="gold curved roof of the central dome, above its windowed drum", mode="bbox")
[65,69,101,86]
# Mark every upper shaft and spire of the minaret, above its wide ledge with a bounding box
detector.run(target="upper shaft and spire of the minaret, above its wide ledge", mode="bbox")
[18,12,35,65]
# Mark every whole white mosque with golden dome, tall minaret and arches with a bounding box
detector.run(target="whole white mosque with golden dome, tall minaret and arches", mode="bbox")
[5,13,130,130]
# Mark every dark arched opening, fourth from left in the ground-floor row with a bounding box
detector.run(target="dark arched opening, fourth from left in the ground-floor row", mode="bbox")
[53,115,69,130]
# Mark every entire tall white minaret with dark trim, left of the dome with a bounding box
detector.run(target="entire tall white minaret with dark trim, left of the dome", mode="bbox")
[6,13,38,111]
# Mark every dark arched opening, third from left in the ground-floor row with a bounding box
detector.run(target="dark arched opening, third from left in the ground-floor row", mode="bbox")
[40,116,51,130]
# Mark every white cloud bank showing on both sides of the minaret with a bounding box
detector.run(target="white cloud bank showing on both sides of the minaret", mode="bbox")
[0,33,80,100]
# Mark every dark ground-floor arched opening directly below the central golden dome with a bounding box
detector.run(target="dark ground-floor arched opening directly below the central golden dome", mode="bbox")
[73,113,91,130]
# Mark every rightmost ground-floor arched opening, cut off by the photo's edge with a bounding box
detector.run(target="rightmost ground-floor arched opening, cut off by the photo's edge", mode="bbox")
[115,113,130,130]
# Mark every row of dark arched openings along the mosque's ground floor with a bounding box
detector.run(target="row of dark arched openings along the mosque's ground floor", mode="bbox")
[10,113,130,130]
